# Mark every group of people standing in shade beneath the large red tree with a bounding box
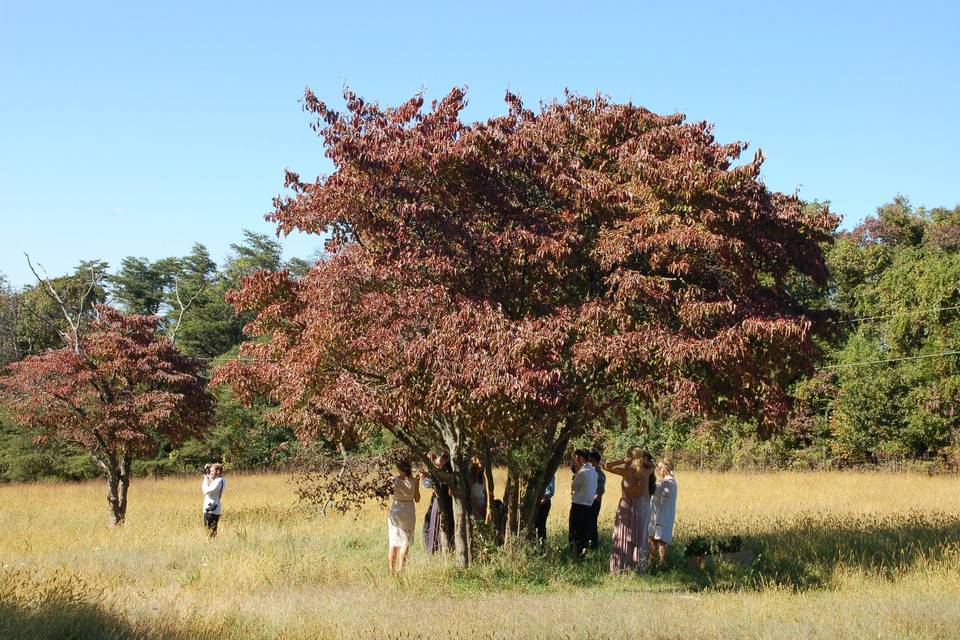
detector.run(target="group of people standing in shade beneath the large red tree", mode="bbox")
[387,447,677,574]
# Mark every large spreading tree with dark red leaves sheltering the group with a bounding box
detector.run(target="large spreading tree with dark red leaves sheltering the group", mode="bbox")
[218,89,837,562]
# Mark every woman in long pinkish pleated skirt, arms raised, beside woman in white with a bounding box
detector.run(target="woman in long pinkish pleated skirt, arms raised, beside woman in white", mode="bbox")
[603,447,654,574]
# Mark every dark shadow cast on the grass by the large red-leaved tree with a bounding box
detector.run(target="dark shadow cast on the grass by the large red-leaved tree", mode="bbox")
[448,513,960,593]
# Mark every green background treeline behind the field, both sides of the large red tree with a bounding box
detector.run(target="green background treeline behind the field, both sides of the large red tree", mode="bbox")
[0,198,960,481]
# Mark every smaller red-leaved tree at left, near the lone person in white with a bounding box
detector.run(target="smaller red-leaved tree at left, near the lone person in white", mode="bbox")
[0,306,213,524]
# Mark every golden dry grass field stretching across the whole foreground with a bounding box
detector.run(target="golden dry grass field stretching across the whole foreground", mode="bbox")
[0,470,960,640]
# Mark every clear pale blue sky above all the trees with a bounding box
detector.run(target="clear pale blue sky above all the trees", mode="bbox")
[0,0,960,284]
